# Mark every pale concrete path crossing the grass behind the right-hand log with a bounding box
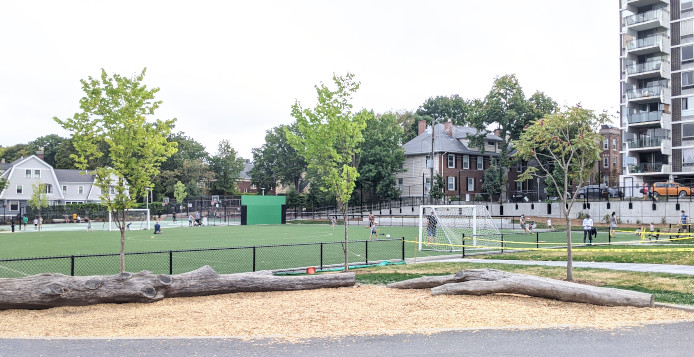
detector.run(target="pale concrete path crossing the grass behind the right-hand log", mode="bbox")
[406,256,694,275]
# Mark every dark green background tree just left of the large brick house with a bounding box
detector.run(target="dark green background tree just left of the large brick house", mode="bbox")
[357,113,405,202]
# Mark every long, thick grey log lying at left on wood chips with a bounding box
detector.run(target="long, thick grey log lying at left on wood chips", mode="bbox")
[0,266,356,309]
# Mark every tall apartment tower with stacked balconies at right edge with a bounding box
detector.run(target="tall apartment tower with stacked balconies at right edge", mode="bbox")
[620,0,694,189]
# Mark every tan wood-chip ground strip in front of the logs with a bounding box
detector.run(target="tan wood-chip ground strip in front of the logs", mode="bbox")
[0,285,694,339]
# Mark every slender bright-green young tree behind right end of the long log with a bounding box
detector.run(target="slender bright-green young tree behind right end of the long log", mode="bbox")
[285,73,372,270]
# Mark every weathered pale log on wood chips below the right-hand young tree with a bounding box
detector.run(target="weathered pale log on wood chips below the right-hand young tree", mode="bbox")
[389,269,654,307]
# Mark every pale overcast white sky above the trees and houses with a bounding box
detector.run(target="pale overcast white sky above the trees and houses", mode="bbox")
[0,0,619,159]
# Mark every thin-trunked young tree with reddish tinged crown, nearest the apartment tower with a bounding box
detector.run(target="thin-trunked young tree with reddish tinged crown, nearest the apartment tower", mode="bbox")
[515,106,608,281]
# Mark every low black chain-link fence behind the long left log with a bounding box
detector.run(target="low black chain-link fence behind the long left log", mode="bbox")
[0,238,405,278]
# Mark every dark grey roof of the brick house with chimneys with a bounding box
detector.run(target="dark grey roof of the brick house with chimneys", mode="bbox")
[403,124,502,156]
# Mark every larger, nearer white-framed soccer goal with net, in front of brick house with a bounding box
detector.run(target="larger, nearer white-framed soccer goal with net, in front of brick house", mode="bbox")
[419,205,501,252]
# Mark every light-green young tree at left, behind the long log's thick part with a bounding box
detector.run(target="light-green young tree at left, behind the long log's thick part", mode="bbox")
[53,69,176,272]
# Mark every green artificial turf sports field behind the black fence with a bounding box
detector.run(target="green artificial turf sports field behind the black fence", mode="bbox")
[0,224,664,277]
